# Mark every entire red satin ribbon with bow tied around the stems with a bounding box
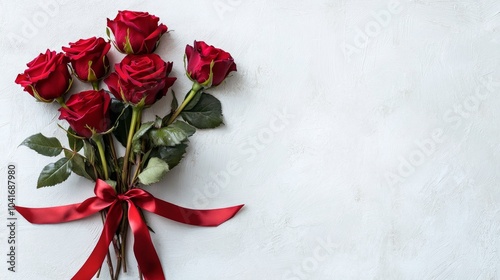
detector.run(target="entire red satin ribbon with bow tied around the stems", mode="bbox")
[16,180,243,280]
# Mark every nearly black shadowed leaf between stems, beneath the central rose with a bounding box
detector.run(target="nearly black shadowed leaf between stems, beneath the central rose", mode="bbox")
[110,98,132,147]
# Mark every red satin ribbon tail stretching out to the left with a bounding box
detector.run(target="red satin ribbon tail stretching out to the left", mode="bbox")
[15,197,110,224]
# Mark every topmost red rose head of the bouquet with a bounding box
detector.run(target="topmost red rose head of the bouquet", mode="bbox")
[108,11,168,54]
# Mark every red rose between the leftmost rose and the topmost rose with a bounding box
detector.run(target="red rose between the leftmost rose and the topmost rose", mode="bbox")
[62,37,111,82]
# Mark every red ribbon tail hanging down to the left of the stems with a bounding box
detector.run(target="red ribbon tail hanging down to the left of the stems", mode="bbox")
[71,202,123,280]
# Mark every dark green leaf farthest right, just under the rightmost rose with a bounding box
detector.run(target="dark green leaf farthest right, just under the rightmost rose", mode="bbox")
[181,93,222,129]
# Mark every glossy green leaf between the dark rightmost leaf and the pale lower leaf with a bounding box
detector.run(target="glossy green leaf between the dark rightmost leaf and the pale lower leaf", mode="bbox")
[149,121,196,146]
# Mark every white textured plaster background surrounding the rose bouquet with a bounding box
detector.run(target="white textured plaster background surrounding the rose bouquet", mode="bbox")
[0,0,500,280]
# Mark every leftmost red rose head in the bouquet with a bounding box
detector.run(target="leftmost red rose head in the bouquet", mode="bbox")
[16,50,73,102]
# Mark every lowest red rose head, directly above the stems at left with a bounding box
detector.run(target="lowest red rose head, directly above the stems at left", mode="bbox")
[59,90,111,138]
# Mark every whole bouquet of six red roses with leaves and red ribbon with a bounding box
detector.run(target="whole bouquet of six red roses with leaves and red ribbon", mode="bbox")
[16,11,243,280]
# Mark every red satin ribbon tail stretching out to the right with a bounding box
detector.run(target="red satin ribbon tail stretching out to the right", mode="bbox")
[132,191,244,226]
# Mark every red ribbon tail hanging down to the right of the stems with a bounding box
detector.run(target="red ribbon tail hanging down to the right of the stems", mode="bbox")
[127,200,165,280]
